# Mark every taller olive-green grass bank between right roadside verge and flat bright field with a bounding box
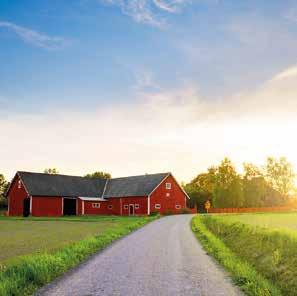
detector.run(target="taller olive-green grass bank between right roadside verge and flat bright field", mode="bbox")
[197,214,297,296]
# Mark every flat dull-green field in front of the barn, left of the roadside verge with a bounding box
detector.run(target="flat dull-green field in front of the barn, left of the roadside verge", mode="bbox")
[0,216,147,263]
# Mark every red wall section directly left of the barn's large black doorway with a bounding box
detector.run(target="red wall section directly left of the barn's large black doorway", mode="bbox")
[32,196,63,217]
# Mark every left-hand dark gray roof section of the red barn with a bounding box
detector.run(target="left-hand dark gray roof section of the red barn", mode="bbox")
[18,172,106,197]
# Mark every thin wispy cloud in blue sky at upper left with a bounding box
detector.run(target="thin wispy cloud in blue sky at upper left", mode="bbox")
[0,21,70,50]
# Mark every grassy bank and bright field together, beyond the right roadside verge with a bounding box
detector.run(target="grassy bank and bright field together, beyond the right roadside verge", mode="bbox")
[192,213,297,295]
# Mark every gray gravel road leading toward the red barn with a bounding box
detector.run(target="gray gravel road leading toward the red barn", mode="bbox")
[36,215,242,296]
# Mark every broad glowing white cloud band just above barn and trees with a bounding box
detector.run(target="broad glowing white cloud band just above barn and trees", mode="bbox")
[0,65,297,180]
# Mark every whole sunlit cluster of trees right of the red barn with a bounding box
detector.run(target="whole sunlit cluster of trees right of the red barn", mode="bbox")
[184,157,295,211]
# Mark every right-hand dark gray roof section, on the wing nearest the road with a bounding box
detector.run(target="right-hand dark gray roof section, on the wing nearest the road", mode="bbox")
[103,173,169,198]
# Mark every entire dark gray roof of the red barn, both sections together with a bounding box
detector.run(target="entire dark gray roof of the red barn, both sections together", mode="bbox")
[13,171,169,198]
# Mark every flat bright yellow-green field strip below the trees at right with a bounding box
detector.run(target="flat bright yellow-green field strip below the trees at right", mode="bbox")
[215,213,297,230]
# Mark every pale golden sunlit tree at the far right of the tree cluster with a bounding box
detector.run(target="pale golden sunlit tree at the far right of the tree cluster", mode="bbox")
[266,157,295,199]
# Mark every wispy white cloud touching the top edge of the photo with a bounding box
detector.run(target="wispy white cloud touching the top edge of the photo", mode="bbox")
[101,0,190,27]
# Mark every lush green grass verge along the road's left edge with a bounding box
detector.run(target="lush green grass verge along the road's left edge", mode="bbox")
[0,217,154,296]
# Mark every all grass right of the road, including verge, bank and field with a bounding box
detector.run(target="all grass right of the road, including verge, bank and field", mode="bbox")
[192,213,297,295]
